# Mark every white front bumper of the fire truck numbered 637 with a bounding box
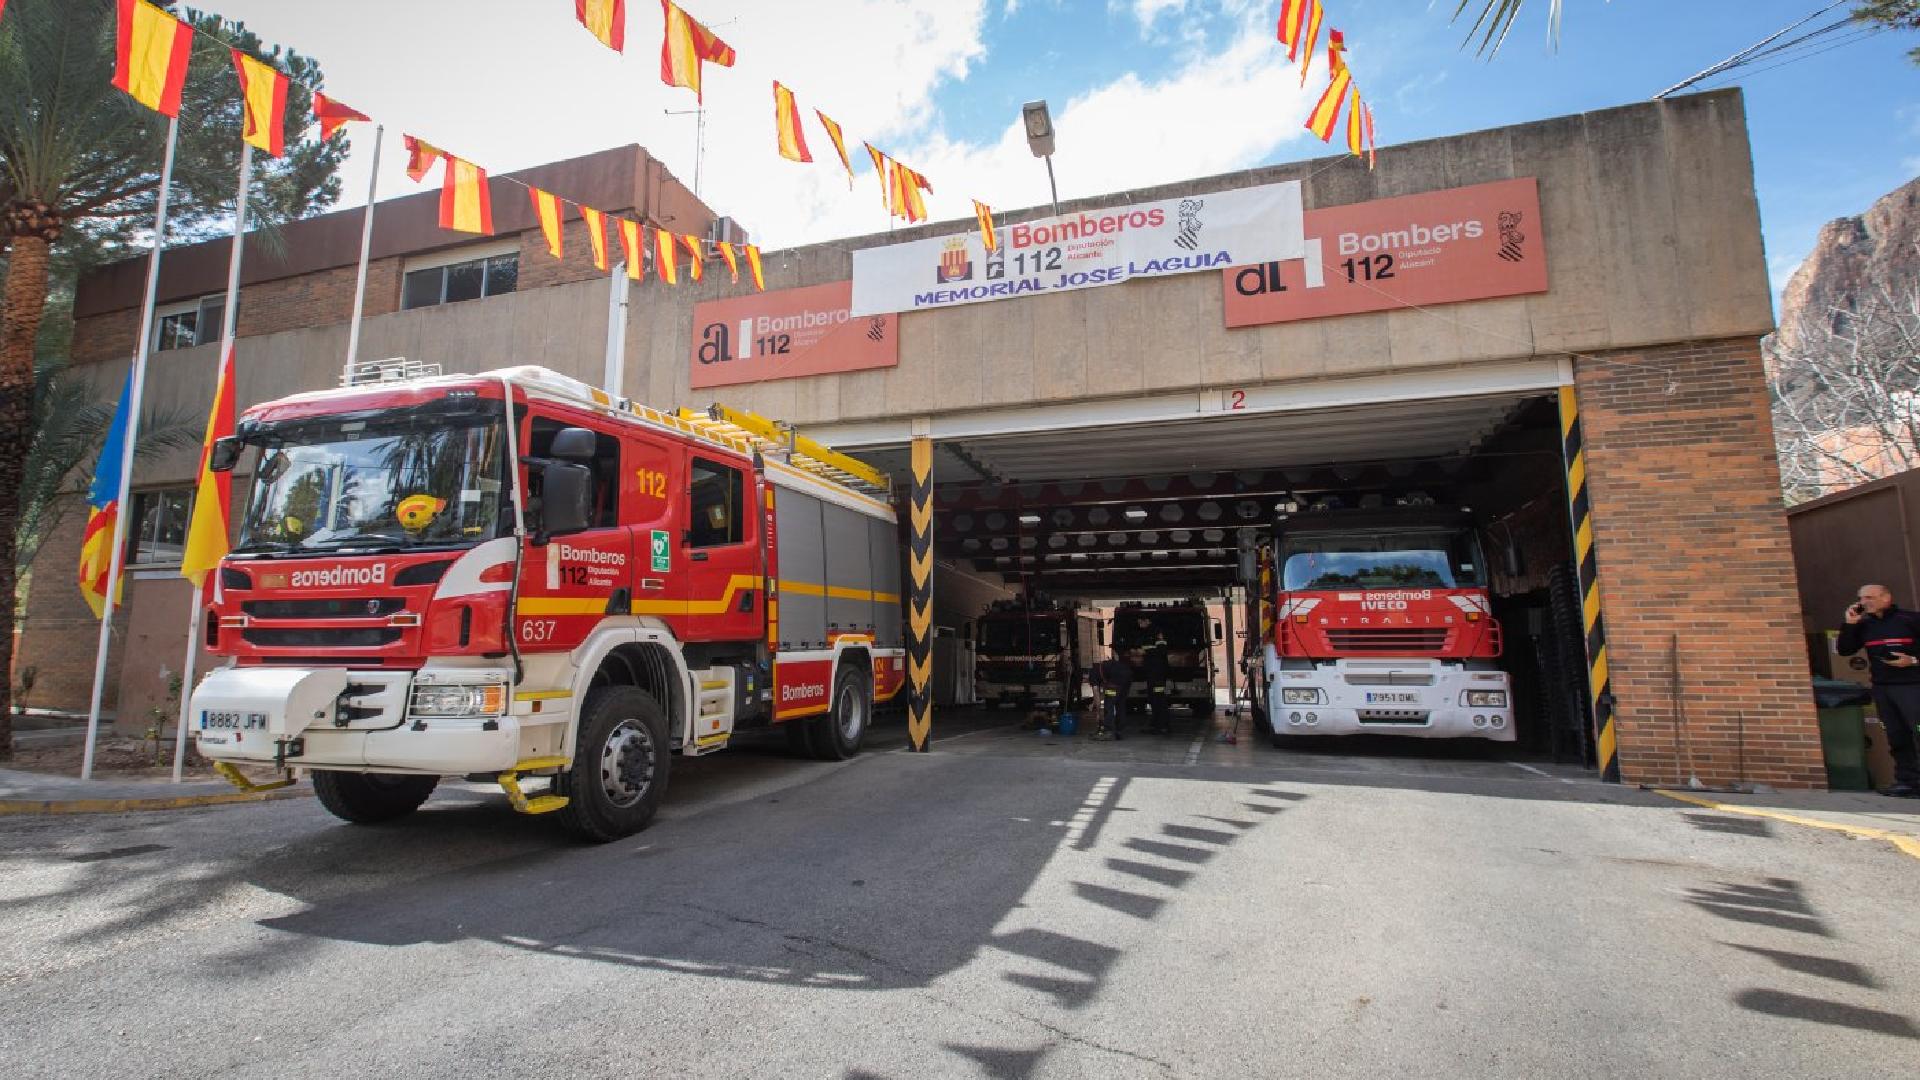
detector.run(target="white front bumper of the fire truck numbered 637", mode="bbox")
[188,667,520,776]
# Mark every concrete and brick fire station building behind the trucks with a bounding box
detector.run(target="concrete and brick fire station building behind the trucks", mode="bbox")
[30,90,1824,788]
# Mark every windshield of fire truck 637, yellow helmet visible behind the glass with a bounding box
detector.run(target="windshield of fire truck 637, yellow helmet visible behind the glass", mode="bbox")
[234,409,505,553]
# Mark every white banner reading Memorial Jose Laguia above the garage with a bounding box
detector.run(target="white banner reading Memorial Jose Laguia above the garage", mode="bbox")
[852,181,1306,315]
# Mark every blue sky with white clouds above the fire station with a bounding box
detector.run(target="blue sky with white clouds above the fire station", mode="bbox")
[196,0,1920,292]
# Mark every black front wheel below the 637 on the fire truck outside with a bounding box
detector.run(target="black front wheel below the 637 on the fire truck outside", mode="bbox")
[553,686,672,842]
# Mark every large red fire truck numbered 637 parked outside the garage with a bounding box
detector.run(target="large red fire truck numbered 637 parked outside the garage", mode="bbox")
[190,367,906,840]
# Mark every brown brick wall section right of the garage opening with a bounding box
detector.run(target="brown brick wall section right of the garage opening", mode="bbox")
[1574,338,1826,788]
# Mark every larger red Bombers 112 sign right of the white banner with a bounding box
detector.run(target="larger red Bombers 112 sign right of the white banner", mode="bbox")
[1221,177,1548,327]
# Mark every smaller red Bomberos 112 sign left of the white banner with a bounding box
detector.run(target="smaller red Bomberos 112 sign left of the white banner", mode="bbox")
[693,281,900,390]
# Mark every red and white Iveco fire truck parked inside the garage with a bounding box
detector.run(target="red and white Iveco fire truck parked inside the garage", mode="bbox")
[1252,505,1515,744]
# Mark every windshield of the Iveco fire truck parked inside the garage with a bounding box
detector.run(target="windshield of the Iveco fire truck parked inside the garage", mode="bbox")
[1281,528,1486,592]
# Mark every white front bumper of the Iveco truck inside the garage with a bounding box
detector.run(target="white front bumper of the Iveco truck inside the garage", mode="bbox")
[1267,657,1515,742]
